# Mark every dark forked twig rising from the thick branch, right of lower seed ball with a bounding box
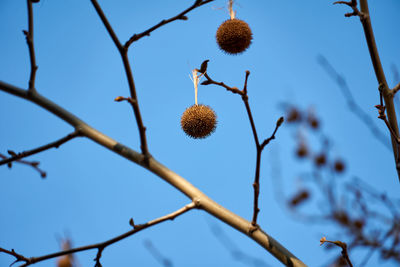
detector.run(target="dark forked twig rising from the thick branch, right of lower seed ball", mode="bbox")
[197,60,283,228]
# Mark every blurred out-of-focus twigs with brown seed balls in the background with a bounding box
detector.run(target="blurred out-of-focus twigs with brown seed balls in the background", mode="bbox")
[282,105,400,266]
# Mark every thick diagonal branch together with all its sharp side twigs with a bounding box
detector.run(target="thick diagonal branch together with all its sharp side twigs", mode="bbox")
[0,0,305,267]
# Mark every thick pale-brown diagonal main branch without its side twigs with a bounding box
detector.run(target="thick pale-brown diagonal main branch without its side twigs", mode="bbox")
[0,81,306,267]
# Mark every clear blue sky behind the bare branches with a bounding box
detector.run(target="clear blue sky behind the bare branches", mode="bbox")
[0,0,400,267]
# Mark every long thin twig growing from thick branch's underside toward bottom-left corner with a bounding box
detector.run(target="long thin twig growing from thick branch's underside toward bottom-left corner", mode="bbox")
[0,202,197,267]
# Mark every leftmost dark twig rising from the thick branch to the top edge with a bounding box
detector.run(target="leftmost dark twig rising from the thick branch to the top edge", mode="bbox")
[22,0,38,91]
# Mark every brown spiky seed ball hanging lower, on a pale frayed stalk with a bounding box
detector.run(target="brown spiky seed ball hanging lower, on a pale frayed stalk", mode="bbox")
[181,105,217,139]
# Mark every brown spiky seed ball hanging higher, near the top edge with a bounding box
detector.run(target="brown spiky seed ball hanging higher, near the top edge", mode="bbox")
[216,19,253,55]
